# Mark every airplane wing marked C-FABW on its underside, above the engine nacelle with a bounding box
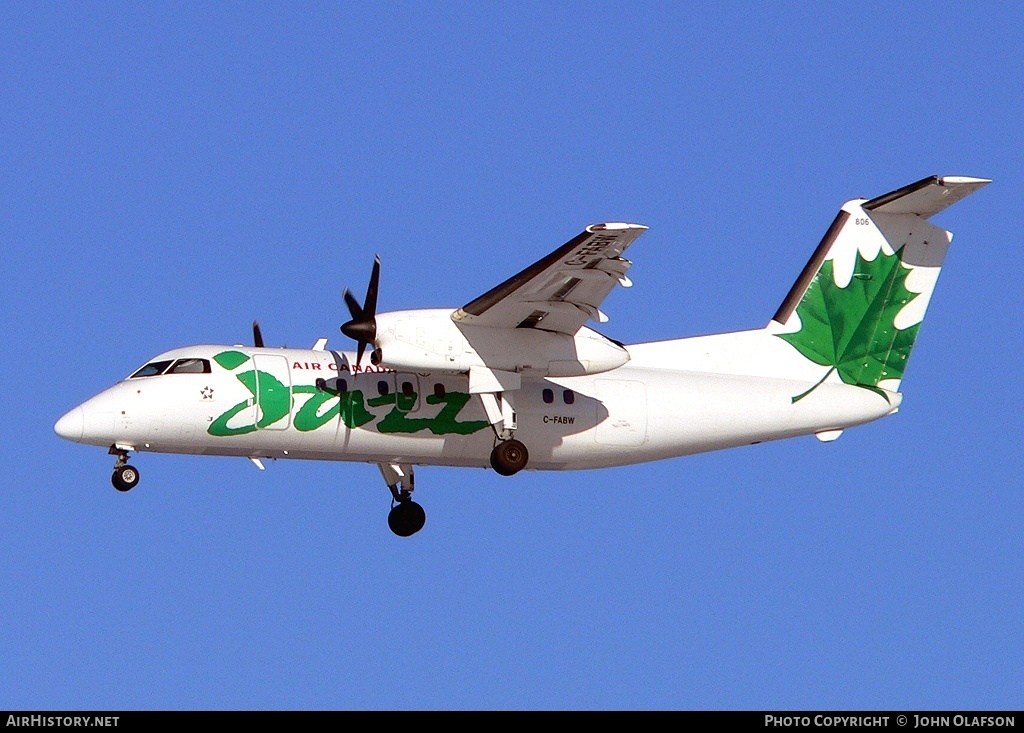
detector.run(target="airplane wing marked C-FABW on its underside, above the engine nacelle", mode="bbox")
[452,223,647,336]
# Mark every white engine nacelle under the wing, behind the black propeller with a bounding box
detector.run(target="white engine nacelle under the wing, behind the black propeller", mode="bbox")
[376,309,630,377]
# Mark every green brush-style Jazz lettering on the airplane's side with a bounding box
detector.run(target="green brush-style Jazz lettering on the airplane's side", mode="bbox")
[207,351,487,436]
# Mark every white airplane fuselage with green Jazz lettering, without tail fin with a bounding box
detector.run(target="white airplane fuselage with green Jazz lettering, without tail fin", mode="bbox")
[56,332,899,470]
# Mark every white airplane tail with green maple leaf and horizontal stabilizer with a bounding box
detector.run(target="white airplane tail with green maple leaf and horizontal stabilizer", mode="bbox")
[768,176,990,401]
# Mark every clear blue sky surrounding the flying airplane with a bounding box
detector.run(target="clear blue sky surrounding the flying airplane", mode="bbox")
[0,2,1024,709]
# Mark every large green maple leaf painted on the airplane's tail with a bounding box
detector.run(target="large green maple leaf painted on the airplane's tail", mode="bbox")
[777,252,921,402]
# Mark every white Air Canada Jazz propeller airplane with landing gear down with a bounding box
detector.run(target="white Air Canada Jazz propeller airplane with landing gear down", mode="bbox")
[54,176,990,536]
